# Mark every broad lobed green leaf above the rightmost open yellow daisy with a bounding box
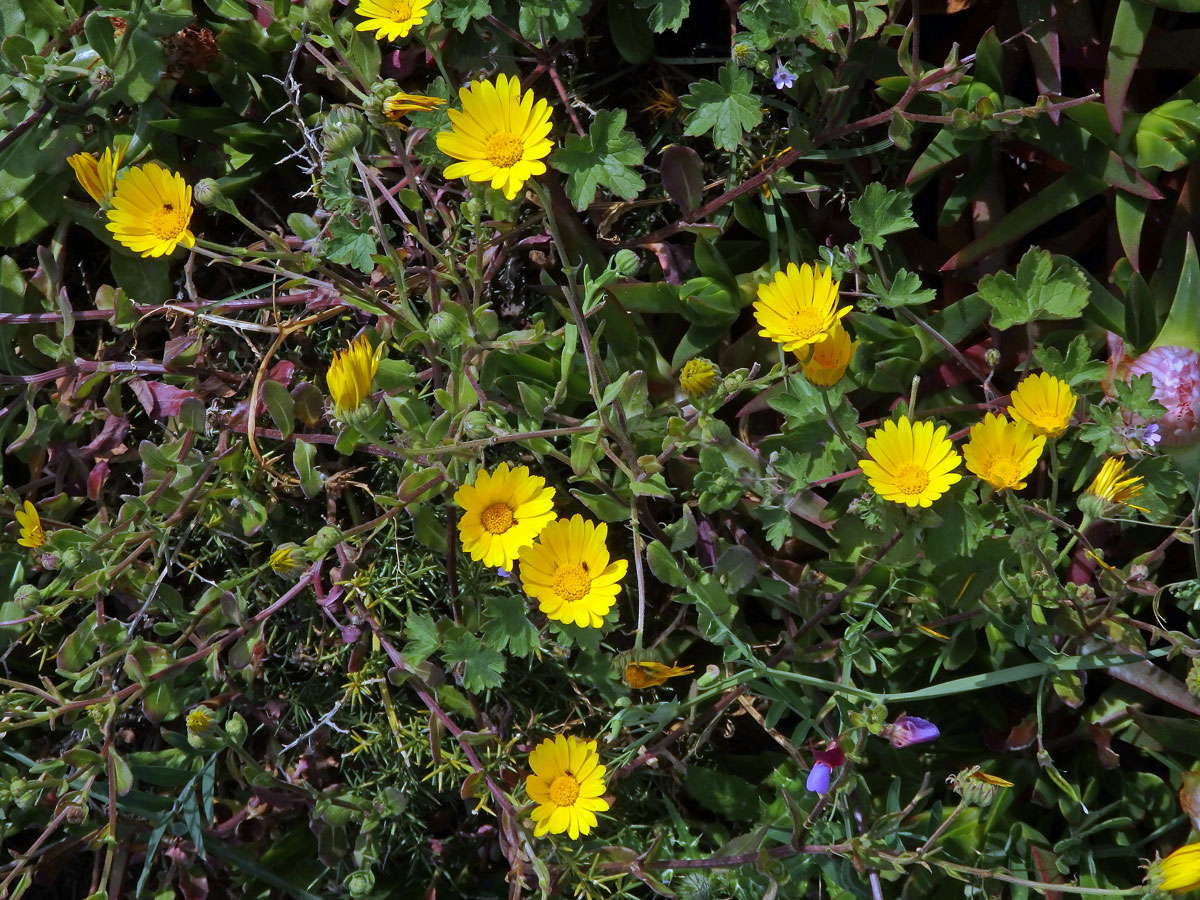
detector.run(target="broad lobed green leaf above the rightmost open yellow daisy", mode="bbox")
[979,247,1091,329]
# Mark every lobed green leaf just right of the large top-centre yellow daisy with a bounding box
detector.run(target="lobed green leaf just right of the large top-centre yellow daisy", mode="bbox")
[551,109,646,210]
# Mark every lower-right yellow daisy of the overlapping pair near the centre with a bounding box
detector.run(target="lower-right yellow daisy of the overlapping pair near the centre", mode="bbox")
[521,514,629,628]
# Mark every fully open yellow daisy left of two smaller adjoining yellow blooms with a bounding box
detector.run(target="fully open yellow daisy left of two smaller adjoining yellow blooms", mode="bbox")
[858,415,962,506]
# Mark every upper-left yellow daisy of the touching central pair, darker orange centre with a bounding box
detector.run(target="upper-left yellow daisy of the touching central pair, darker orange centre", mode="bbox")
[454,462,554,570]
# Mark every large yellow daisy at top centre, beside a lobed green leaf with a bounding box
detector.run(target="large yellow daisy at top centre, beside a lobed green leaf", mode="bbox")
[437,74,554,200]
